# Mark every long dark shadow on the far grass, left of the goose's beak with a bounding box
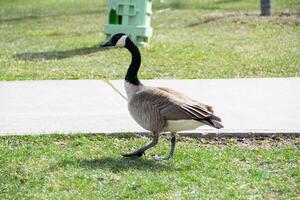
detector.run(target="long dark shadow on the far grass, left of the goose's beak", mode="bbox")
[12,45,108,60]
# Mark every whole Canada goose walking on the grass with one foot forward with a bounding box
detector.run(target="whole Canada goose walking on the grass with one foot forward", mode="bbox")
[101,33,223,160]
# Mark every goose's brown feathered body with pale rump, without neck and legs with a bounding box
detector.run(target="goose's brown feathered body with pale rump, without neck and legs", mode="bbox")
[125,82,222,133]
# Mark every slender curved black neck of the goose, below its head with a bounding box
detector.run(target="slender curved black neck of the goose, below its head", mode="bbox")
[125,38,141,85]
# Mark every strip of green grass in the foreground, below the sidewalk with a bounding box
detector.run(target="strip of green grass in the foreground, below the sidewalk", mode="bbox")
[0,134,300,199]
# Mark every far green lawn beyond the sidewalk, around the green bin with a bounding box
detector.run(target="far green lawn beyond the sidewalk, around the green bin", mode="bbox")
[0,0,300,80]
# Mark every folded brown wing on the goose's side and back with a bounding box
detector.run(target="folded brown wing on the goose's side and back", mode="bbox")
[130,87,221,126]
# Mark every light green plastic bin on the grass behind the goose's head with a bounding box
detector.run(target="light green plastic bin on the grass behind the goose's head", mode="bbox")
[104,0,153,46]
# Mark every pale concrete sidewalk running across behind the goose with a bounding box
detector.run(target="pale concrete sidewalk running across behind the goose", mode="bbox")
[0,78,300,136]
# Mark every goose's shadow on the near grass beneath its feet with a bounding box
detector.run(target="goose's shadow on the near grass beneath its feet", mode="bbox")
[60,157,178,173]
